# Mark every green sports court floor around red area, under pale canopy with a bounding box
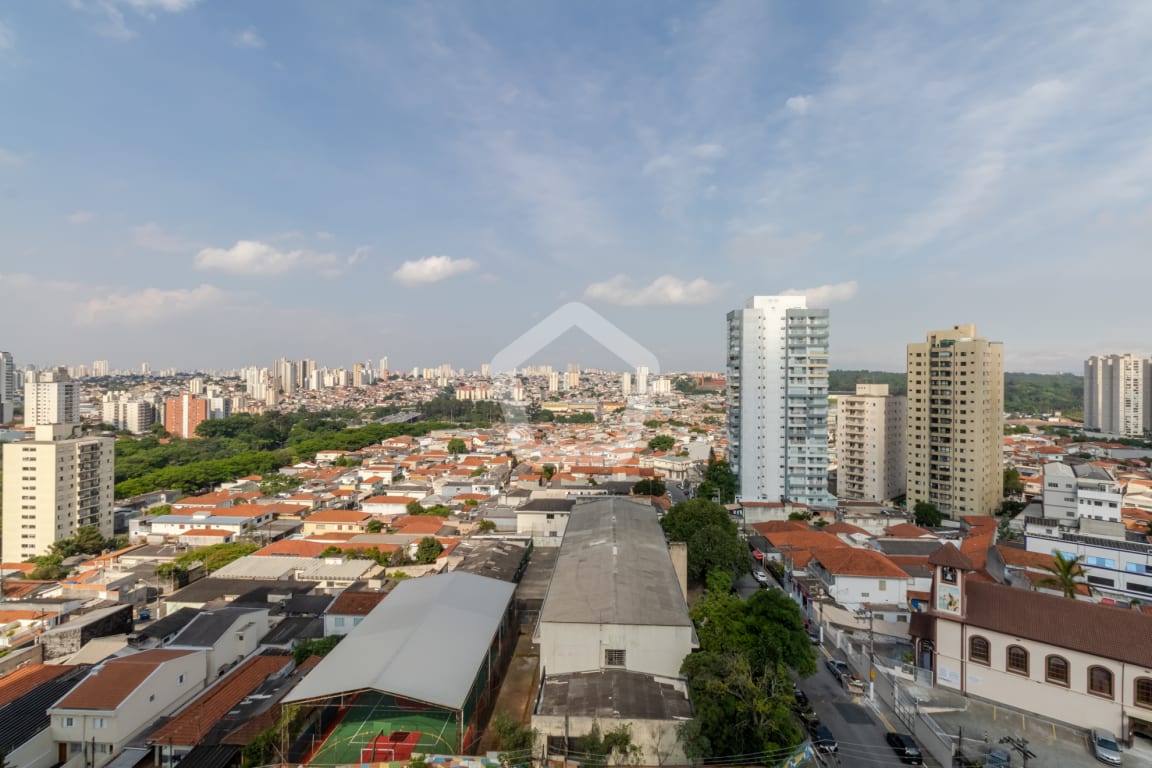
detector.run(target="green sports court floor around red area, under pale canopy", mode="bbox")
[309,691,457,766]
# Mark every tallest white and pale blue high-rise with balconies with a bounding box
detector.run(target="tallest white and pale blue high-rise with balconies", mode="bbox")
[728,296,835,505]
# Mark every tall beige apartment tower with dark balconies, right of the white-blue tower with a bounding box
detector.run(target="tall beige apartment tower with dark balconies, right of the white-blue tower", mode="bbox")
[905,325,1005,518]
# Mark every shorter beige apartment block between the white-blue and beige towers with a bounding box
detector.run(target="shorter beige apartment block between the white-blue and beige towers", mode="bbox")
[836,383,908,501]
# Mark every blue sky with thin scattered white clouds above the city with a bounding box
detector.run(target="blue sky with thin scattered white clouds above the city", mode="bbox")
[0,0,1152,372]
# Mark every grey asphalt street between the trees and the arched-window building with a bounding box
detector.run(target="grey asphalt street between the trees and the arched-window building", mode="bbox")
[799,649,903,768]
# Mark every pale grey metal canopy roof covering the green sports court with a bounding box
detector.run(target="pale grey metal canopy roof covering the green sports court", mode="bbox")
[285,572,516,709]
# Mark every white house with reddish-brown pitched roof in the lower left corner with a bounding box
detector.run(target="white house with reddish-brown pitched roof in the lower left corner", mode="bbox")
[47,648,207,768]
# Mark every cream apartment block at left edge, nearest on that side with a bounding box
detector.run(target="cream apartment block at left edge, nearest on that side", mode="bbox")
[0,424,115,563]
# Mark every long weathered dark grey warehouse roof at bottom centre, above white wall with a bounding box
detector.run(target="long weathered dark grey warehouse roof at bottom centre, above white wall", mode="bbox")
[540,496,692,626]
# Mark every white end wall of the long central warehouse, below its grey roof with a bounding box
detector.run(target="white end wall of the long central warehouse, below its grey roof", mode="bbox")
[540,622,692,677]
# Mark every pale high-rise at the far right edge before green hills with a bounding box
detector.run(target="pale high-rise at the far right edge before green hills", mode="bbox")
[1084,355,1152,438]
